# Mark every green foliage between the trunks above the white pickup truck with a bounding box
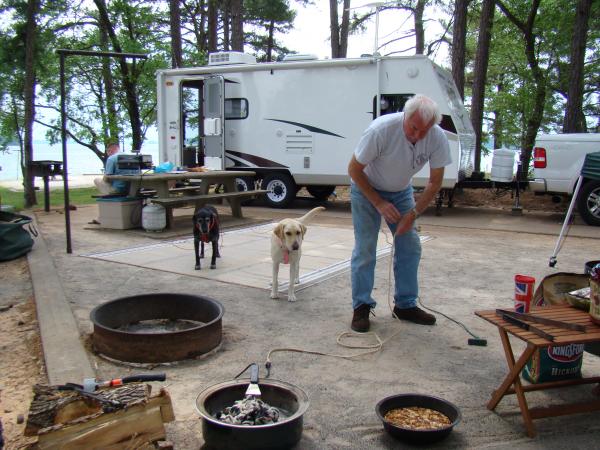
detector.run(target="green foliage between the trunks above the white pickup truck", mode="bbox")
[466,0,600,152]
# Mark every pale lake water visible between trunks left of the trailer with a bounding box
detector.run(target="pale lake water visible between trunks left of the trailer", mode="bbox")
[0,141,159,181]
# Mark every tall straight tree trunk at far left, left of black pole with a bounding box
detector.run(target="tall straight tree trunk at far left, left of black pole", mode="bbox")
[22,0,40,208]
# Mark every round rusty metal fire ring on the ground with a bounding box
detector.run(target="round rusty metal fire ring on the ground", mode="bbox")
[90,293,225,363]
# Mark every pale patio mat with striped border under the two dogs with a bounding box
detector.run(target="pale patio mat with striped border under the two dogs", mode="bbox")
[81,223,428,292]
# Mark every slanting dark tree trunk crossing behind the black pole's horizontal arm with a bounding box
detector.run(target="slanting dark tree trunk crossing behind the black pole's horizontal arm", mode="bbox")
[94,0,142,150]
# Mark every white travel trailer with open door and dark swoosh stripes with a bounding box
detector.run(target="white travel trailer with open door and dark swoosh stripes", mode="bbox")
[157,52,475,207]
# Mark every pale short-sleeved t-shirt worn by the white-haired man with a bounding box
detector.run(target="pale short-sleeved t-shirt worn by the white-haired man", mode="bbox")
[354,113,452,192]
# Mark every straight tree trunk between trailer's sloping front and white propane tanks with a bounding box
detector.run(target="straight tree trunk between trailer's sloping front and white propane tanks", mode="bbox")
[472,0,495,172]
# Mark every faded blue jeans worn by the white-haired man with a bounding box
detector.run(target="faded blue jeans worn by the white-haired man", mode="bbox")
[351,184,421,309]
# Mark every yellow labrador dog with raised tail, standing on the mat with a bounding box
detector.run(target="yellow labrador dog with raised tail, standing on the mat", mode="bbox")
[271,206,325,302]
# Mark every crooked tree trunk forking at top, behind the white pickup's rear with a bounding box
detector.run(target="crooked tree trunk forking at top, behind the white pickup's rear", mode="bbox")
[496,0,546,178]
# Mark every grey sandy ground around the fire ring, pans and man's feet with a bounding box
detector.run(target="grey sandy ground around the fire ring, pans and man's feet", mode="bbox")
[23,202,600,450]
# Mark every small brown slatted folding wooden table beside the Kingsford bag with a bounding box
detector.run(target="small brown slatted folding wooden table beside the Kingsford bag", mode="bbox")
[475,305,600,437]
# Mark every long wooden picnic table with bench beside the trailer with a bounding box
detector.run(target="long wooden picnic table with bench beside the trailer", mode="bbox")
[106,170,266,227]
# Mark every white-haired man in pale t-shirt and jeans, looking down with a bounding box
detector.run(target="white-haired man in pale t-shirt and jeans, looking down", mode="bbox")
[348,95,451,332]
